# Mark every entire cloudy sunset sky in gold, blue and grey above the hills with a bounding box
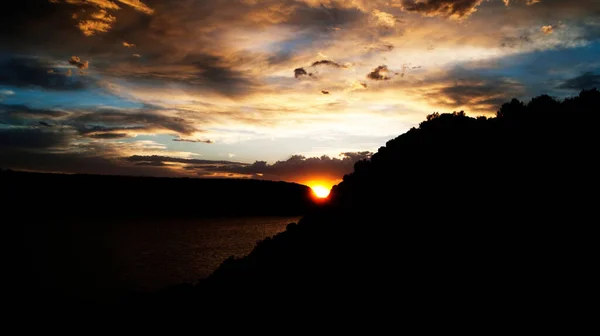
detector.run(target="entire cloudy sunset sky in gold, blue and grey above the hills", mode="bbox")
[0,0,600,187]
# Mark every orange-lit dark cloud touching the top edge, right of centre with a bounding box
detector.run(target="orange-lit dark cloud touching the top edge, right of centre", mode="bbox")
[401,0,483,18]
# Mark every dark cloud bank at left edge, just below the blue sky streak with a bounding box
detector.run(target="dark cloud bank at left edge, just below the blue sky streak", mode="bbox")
[0,128,69,150]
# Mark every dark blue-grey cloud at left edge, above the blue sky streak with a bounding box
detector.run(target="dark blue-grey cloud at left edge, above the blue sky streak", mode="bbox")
[0,57,92,90]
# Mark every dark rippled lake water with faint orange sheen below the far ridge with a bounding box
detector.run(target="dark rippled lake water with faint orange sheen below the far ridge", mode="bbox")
[23,217,300,297]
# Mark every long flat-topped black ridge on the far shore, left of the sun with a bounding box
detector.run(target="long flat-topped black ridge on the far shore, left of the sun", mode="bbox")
[0,171,315,221]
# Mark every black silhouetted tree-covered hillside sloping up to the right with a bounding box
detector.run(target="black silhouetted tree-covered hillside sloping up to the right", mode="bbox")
[130,90,600,318]
